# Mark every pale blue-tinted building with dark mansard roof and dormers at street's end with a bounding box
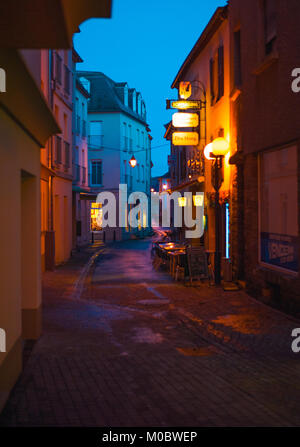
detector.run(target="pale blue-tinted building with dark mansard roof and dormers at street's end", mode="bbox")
[78,71,151,241]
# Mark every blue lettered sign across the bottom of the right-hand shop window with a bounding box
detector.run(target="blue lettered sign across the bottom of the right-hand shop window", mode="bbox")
[260,232,299,272]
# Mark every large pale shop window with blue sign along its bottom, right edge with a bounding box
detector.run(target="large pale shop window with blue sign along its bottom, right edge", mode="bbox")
[260,146,299,272]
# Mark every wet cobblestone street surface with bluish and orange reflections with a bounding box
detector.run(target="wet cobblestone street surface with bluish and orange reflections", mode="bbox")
[0,240,300,427]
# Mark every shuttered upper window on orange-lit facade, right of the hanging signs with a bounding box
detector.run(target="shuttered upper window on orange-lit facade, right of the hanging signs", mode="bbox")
[209,45,224,105]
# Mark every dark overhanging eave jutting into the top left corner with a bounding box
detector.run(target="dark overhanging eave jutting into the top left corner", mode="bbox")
[0,0,112,49]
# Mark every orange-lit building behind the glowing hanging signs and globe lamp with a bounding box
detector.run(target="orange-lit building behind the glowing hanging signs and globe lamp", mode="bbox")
[166,6,235,280]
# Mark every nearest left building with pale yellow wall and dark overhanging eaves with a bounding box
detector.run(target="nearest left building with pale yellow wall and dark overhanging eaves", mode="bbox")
[0,0,111,411]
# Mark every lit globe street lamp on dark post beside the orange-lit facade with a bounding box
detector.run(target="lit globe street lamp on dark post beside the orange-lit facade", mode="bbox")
[204,137,229,285]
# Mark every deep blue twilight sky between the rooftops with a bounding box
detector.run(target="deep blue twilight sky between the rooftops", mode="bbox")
[74,0,227,176]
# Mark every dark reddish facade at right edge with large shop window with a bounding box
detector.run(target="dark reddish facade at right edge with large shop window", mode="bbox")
[229,0,300,310]
